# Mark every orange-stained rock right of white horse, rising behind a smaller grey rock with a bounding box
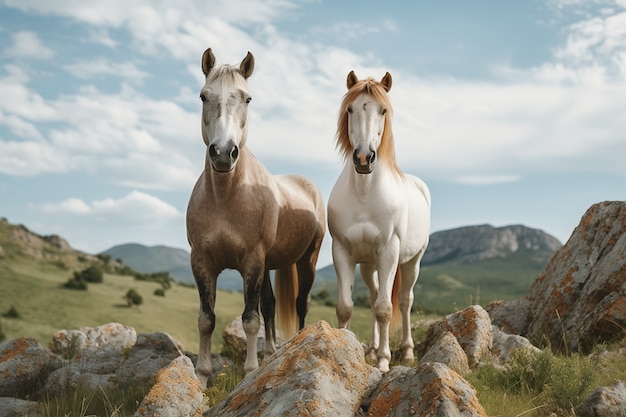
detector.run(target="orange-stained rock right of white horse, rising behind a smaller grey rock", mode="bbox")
[426,305,493,369]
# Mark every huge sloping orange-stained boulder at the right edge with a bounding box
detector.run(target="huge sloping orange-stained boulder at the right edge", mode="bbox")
[487,201,626,352]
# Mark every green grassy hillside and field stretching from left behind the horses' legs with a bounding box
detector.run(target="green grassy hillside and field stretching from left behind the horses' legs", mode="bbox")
[0,219,370,352]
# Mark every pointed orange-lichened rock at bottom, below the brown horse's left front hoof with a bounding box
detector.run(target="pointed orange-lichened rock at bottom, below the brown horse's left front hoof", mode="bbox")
[135,356,203,417]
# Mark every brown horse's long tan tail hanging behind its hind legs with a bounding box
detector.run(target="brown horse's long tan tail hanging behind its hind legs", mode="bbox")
[274,264,300,340]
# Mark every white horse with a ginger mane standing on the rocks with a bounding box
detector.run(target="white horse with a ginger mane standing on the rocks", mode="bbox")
[327,71,430,372]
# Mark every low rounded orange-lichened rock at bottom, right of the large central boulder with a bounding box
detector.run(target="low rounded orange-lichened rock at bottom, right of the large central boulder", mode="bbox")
[359,362,487,417]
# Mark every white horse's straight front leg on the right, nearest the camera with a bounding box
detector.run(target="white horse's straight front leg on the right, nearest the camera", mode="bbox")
[373,244,398,372]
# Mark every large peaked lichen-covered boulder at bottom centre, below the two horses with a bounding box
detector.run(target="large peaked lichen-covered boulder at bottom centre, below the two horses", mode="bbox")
[204,321,382,417]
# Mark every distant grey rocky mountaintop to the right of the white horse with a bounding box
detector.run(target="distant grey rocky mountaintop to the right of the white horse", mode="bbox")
[422,225,561,265]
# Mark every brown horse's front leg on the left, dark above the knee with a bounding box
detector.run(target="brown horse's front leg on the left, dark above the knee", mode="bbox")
[192,263,217,388]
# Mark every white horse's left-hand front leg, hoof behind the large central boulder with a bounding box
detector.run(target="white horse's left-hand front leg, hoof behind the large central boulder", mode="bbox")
[333,240,356,328]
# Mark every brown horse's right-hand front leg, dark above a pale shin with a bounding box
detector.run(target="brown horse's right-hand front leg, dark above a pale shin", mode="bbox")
[241,265,264,373]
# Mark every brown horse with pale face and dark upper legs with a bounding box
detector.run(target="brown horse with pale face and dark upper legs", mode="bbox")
[187,48,326,386]
